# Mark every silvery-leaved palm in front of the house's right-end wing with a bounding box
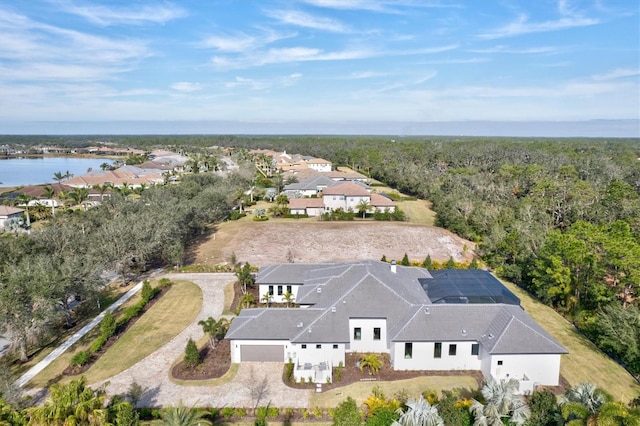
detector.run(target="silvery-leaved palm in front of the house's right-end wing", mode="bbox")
[469,378,531,426]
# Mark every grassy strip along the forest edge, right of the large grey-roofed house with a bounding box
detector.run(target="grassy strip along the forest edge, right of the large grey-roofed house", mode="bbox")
[503,281,640,403]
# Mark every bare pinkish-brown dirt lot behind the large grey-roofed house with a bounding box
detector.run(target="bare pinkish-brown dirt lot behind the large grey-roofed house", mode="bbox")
[189,217,475,266]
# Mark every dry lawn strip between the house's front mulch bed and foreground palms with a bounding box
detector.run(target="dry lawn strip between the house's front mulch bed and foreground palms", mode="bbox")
[309,376,478,408]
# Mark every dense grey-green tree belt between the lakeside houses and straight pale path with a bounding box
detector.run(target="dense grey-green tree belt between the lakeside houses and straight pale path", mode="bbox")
[0,173,248,360]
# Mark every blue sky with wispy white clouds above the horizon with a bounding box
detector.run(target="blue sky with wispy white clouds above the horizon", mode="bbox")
[0,0,640,133]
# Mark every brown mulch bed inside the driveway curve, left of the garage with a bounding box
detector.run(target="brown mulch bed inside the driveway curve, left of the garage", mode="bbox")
[171,340,231,380]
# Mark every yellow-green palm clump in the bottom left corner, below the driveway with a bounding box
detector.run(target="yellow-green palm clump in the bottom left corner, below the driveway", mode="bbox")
[28,376,107,425]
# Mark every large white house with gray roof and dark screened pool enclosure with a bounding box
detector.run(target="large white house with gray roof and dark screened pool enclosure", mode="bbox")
[226,260,567,392]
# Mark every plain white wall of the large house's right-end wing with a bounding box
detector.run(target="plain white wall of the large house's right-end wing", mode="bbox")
[483,354,561,386]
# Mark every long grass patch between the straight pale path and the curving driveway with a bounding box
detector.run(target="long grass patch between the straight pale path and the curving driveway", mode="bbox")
[79,281,202,383]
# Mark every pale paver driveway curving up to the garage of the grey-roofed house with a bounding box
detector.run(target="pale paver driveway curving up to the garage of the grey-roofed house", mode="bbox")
[92,273,310,408]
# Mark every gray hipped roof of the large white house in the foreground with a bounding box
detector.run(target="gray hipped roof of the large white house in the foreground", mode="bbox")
[227,260,567,354]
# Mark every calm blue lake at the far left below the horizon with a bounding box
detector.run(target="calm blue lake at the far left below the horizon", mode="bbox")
[0,157,112,186]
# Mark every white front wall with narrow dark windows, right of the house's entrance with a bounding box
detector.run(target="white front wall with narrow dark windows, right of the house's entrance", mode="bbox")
[391,341,482,370]
